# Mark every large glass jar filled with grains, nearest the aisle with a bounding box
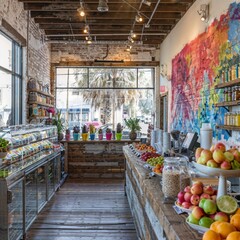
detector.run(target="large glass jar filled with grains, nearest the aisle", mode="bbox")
[162,157,180,203]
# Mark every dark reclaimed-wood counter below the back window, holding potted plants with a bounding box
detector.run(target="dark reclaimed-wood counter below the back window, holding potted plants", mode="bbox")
[62,140,138,179]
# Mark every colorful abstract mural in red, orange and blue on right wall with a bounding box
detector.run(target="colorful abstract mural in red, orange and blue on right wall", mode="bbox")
[171,3,240,138]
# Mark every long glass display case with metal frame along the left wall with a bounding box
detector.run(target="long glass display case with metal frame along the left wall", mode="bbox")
[0,125,61,240]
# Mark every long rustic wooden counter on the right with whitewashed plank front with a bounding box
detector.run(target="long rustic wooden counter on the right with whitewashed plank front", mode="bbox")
[123,146,202,240]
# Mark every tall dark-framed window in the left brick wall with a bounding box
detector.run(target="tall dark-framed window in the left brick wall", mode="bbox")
[0,31,22,127]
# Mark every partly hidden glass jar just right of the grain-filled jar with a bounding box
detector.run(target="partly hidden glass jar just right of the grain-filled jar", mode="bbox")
[179,158,191,191]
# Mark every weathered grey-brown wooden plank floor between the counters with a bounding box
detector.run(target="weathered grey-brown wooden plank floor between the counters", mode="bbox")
[26,179,137,240]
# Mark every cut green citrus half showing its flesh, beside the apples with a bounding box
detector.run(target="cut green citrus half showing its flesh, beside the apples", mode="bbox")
[217,195,238,214]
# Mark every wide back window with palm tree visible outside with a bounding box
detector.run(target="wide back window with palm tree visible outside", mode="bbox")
[56,67,154,134]
